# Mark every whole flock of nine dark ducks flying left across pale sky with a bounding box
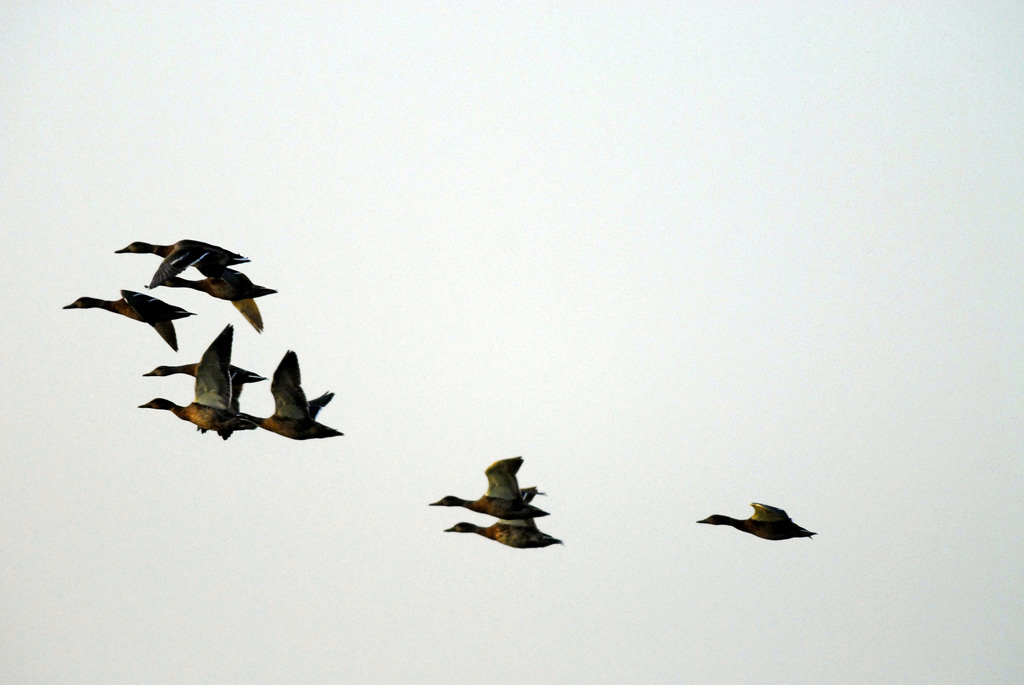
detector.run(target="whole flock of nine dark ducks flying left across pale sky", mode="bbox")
[63,241,817,549]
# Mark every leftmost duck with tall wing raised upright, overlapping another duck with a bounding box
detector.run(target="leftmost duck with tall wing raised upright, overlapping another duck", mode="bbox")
[139,324,256,440]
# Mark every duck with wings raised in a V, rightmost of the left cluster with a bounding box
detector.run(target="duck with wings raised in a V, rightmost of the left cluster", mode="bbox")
[246,350,344,440]
